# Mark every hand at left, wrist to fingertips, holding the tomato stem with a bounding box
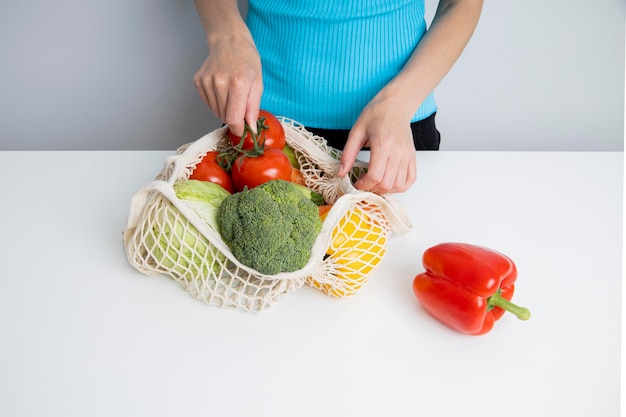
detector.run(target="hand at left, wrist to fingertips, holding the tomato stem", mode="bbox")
[194,33,263,136]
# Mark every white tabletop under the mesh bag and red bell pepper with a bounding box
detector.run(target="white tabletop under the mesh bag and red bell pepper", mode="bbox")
[0,151,624,417]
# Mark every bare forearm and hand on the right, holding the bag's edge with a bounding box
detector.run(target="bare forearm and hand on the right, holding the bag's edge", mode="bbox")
[339,0,483,193]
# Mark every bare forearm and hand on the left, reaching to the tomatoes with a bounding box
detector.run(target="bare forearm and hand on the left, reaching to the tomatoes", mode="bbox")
[194,0,263,135]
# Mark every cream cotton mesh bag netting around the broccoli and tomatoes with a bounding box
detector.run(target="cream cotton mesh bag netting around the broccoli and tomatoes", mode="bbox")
[124,118,412,311]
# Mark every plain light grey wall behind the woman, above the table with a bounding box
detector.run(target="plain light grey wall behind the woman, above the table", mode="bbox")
[0,0,625,151]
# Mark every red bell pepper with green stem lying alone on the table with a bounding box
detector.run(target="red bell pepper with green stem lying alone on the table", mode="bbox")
[413,243,530,335]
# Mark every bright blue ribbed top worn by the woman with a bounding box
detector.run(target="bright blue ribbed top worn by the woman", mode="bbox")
[247,0,437,129]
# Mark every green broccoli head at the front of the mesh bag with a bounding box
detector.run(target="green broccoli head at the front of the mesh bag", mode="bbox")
[217,180,322,275]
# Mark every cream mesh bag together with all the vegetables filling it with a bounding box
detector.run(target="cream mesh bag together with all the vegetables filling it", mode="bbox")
[124,111,411,311]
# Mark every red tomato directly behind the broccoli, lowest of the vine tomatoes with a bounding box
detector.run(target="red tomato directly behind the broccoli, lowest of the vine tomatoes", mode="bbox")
[231,148,291,191]
